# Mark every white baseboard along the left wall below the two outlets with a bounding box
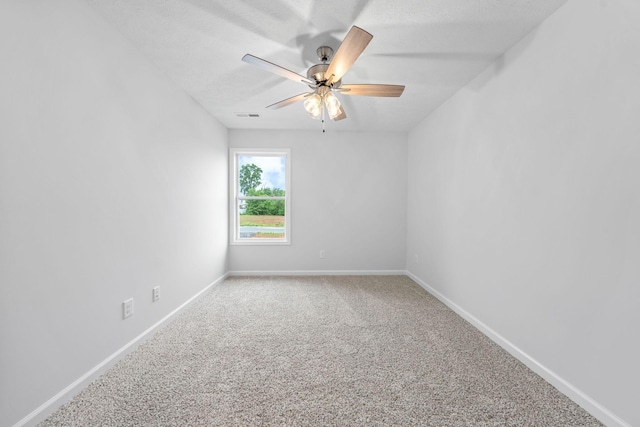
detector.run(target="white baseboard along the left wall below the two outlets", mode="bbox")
[13,273,229,427]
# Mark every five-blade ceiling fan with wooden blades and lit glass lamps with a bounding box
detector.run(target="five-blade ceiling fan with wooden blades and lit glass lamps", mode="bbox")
[242,26,404,131]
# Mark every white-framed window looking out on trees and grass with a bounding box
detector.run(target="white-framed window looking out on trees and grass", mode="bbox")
[230,148,291,245]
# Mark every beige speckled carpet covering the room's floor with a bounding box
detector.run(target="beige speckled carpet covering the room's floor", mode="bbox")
[42,276,601,427]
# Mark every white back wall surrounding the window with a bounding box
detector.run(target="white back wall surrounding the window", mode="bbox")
[229,129,407,272]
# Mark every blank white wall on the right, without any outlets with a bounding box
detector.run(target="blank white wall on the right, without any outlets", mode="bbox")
[407,0,640,425]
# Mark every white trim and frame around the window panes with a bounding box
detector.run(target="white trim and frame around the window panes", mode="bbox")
[229,148,291,246]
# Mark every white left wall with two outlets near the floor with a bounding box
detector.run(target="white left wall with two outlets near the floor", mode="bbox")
[0,0,228,426]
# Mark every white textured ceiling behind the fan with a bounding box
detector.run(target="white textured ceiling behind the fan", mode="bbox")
[86,0,566,131]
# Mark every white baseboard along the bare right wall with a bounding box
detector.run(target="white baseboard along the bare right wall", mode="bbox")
[406,271,631,427]
